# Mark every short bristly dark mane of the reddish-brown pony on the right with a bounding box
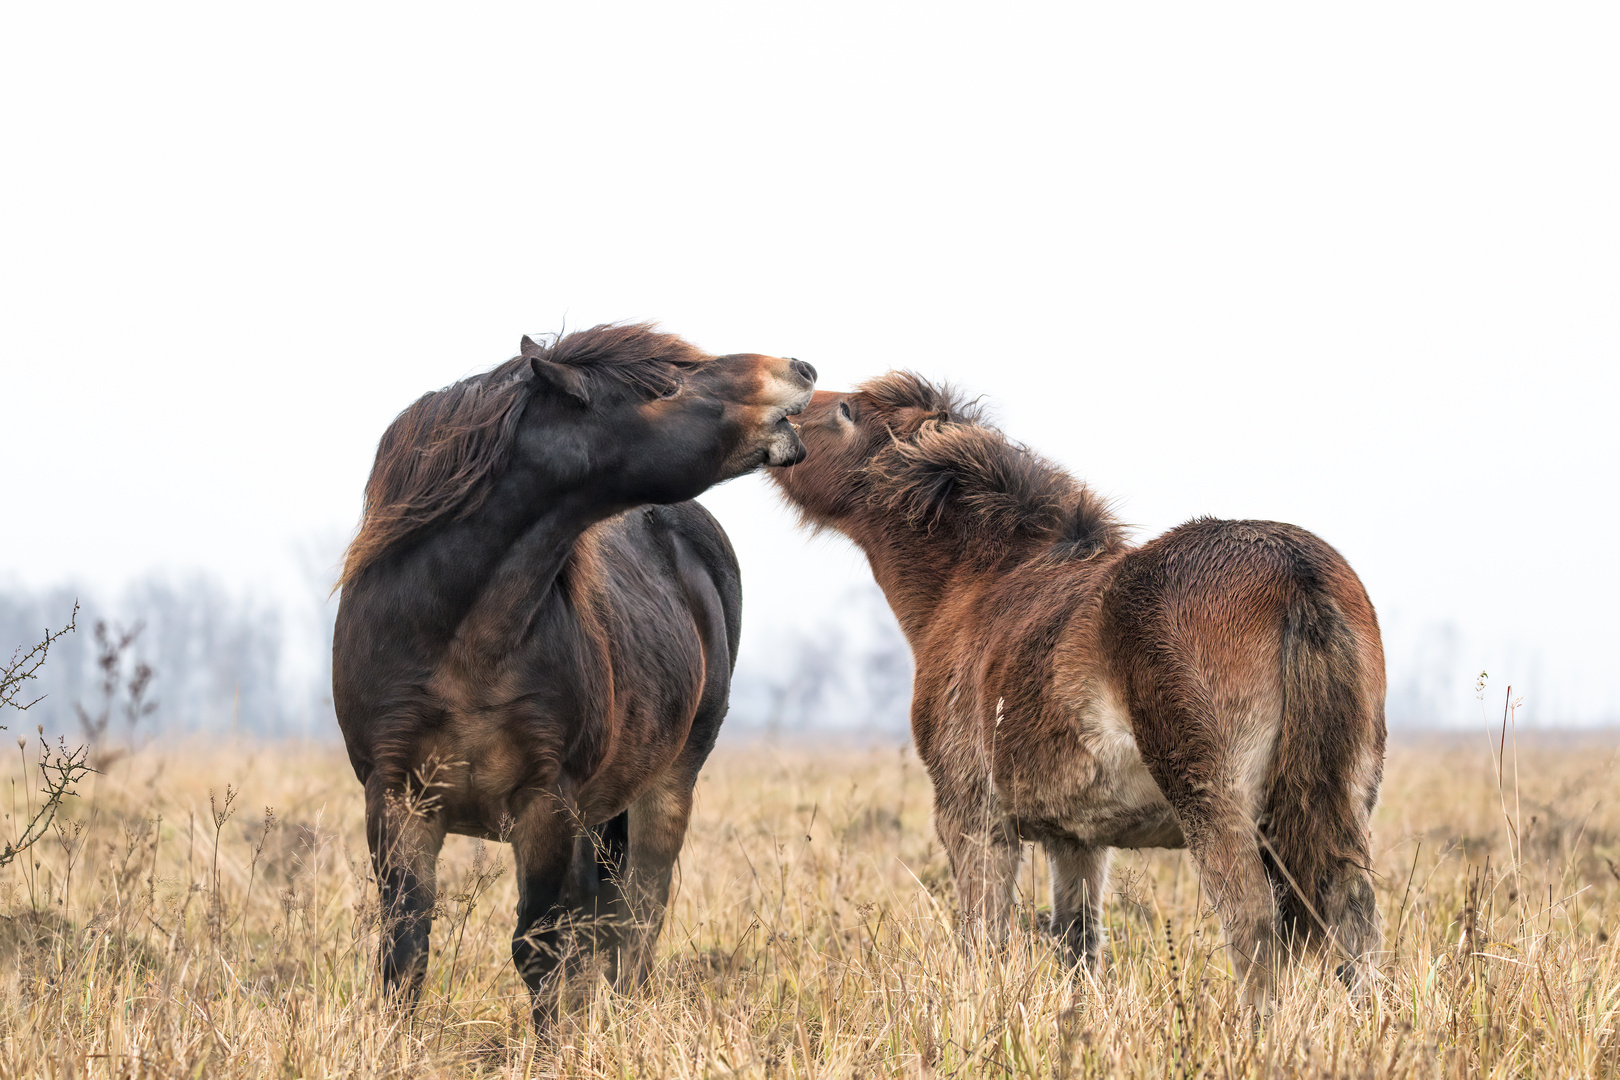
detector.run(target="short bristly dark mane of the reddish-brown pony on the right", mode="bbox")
[860,371,1124,562]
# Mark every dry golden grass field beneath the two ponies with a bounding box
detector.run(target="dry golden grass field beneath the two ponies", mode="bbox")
[0,733,1620,1078]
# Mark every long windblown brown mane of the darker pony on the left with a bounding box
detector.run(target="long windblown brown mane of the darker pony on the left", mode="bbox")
[339,322,710,588]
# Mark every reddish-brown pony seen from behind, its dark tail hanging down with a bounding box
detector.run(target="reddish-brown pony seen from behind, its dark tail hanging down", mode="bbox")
[770,374,1383,1002]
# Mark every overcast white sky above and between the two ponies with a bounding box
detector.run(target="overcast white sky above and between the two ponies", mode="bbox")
[0,3,1620,722]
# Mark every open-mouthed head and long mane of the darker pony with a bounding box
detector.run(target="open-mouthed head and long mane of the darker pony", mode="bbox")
[340,324,815,585]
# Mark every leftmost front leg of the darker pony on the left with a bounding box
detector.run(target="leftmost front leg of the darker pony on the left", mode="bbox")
[366,776,444,1004]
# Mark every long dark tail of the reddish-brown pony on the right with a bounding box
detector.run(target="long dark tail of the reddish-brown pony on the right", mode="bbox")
[1260,583,1382,955]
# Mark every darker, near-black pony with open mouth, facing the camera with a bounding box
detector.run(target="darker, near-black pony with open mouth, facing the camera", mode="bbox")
[332,325,815,1020]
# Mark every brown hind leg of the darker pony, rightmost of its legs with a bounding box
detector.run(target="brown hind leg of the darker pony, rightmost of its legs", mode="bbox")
[616,771,697,989]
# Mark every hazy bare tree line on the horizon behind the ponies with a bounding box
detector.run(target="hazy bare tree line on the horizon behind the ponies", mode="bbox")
[0,572,1574,744]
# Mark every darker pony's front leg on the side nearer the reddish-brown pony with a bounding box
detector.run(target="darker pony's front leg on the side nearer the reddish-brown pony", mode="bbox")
[509,795,577,1030]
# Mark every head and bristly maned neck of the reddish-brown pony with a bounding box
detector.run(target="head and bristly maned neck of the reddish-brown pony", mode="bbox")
[770,371,1123,560]
